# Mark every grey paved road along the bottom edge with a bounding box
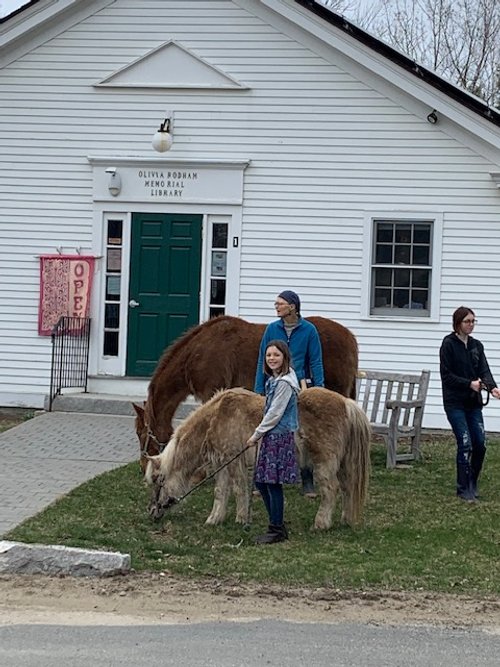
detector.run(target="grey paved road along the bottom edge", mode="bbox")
[0,620,500,667]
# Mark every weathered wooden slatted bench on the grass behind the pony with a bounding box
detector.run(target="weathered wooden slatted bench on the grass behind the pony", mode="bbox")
[356,370,430,468]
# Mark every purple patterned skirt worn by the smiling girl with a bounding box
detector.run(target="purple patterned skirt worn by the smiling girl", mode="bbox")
[255,431,299,484]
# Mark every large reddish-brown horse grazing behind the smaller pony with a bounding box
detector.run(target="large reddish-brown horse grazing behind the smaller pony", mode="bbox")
[135,315,358,454]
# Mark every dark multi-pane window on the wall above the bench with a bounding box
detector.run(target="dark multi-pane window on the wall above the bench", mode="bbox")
[370,218,434,317]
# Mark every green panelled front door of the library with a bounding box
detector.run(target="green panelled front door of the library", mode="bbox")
[127,213,202,377]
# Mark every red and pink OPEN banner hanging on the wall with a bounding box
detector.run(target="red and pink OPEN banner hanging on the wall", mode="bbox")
[38,255,95,336]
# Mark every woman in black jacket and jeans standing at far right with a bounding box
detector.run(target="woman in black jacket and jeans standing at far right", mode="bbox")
[439,306,500,501]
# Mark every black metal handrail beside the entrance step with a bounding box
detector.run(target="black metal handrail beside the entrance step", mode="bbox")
[49,315,90,412]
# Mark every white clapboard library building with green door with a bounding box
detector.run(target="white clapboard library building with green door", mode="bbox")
[0,0,500,431]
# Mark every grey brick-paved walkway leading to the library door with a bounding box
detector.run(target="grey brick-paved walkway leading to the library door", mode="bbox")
[0,412,139,536]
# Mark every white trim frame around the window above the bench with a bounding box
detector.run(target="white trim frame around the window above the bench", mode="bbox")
[361,211,443,322]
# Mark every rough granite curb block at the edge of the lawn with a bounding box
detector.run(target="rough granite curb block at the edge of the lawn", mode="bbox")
[0,540,130,577]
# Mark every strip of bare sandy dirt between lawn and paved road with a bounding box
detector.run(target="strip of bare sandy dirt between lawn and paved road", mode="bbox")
[0,573,500,634]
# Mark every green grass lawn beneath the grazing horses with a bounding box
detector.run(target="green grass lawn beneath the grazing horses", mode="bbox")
[5,439,500,594]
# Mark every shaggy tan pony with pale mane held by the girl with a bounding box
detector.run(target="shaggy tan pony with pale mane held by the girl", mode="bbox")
[145,388,371,530]
